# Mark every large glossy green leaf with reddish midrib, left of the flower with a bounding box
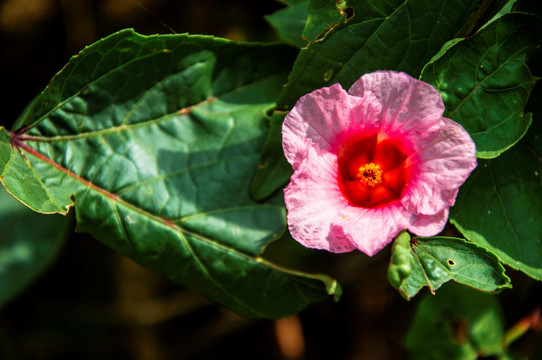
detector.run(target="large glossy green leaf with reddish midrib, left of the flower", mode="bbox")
[0,30,340,318]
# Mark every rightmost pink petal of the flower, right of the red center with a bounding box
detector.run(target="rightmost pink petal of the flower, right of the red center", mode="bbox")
[402,118,476,215]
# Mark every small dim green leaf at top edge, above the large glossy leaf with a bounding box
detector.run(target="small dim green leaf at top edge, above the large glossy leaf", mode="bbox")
[265,0,309,48]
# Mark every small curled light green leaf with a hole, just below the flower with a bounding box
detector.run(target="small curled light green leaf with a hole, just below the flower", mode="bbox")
[388,232,511,300]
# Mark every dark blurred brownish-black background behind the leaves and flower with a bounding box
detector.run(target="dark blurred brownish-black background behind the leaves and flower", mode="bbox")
[0,0,542,360]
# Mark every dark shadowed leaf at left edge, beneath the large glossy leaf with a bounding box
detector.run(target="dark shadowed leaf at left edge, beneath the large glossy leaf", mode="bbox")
[0,188,71,308]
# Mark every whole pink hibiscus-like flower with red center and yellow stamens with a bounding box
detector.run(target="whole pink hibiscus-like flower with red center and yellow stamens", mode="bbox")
[282,71,476,256]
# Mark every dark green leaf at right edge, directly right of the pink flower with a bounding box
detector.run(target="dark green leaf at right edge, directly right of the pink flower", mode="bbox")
[450,143,542,280]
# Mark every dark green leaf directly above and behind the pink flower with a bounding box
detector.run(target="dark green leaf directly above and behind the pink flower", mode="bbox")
[253,0,504,194]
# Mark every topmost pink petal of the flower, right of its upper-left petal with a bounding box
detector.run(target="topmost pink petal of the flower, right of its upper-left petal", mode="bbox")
[348,71,444,149]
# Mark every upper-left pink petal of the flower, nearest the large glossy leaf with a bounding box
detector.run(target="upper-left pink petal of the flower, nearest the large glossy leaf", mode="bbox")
[282,84,380,170]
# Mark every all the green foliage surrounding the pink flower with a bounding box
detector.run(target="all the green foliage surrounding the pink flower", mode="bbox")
[0,0,542,358]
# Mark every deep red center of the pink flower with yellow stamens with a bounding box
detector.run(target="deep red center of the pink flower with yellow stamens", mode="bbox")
[338,135,407,208]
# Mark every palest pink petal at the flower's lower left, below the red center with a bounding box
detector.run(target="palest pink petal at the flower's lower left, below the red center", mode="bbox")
[284,147,415,256]
